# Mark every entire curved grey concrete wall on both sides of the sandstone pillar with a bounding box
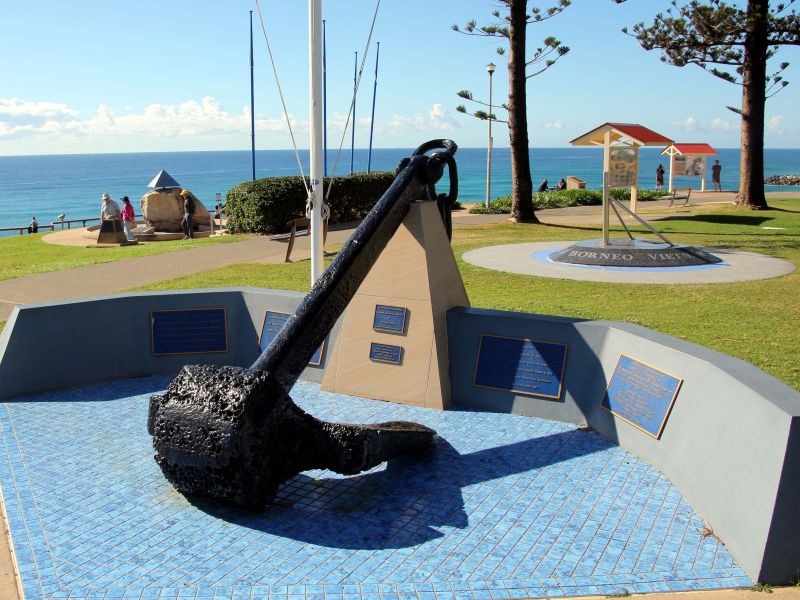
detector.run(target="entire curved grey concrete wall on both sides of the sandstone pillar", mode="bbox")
[0,298,800,583]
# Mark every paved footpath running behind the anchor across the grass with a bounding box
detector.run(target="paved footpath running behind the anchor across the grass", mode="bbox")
[0,192,800,321]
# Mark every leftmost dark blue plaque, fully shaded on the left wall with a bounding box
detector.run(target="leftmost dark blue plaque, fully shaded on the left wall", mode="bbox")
[150,308,228,354]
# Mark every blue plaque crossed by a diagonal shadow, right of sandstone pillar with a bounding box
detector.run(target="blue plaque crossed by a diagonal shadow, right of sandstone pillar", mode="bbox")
[473,335,567,400]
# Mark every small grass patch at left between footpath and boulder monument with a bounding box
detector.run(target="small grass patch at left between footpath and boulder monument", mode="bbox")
[0,233,253,281]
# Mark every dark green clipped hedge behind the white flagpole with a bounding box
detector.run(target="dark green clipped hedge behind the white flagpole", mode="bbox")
[225,171,395,235]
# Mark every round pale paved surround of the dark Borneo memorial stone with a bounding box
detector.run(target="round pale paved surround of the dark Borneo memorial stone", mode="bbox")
[463,241,794,284]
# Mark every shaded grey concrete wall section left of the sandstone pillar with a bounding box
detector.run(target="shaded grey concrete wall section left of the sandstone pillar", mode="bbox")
[0,288,339,400]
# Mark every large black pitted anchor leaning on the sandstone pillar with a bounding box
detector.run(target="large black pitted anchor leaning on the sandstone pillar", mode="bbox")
[147,140,457,510]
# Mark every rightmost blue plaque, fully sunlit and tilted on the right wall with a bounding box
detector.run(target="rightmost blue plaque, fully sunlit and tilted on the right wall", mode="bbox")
[600,354,683,439]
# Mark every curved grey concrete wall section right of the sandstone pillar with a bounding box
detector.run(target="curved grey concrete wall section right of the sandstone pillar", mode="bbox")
[448,308,800,583]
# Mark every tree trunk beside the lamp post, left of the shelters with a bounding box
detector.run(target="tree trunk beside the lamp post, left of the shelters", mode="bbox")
[508,0,539,223]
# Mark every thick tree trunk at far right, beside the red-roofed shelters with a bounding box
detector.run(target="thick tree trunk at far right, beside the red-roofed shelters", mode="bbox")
[737,0,769,210]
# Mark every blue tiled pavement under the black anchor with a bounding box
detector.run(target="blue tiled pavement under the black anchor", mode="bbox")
[0,377,751,600]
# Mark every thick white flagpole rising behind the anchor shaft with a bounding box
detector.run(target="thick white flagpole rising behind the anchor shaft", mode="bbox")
[308,0,325,285]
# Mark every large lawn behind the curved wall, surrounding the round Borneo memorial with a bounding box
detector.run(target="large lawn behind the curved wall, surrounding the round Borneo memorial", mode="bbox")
[130,200,800,389]
